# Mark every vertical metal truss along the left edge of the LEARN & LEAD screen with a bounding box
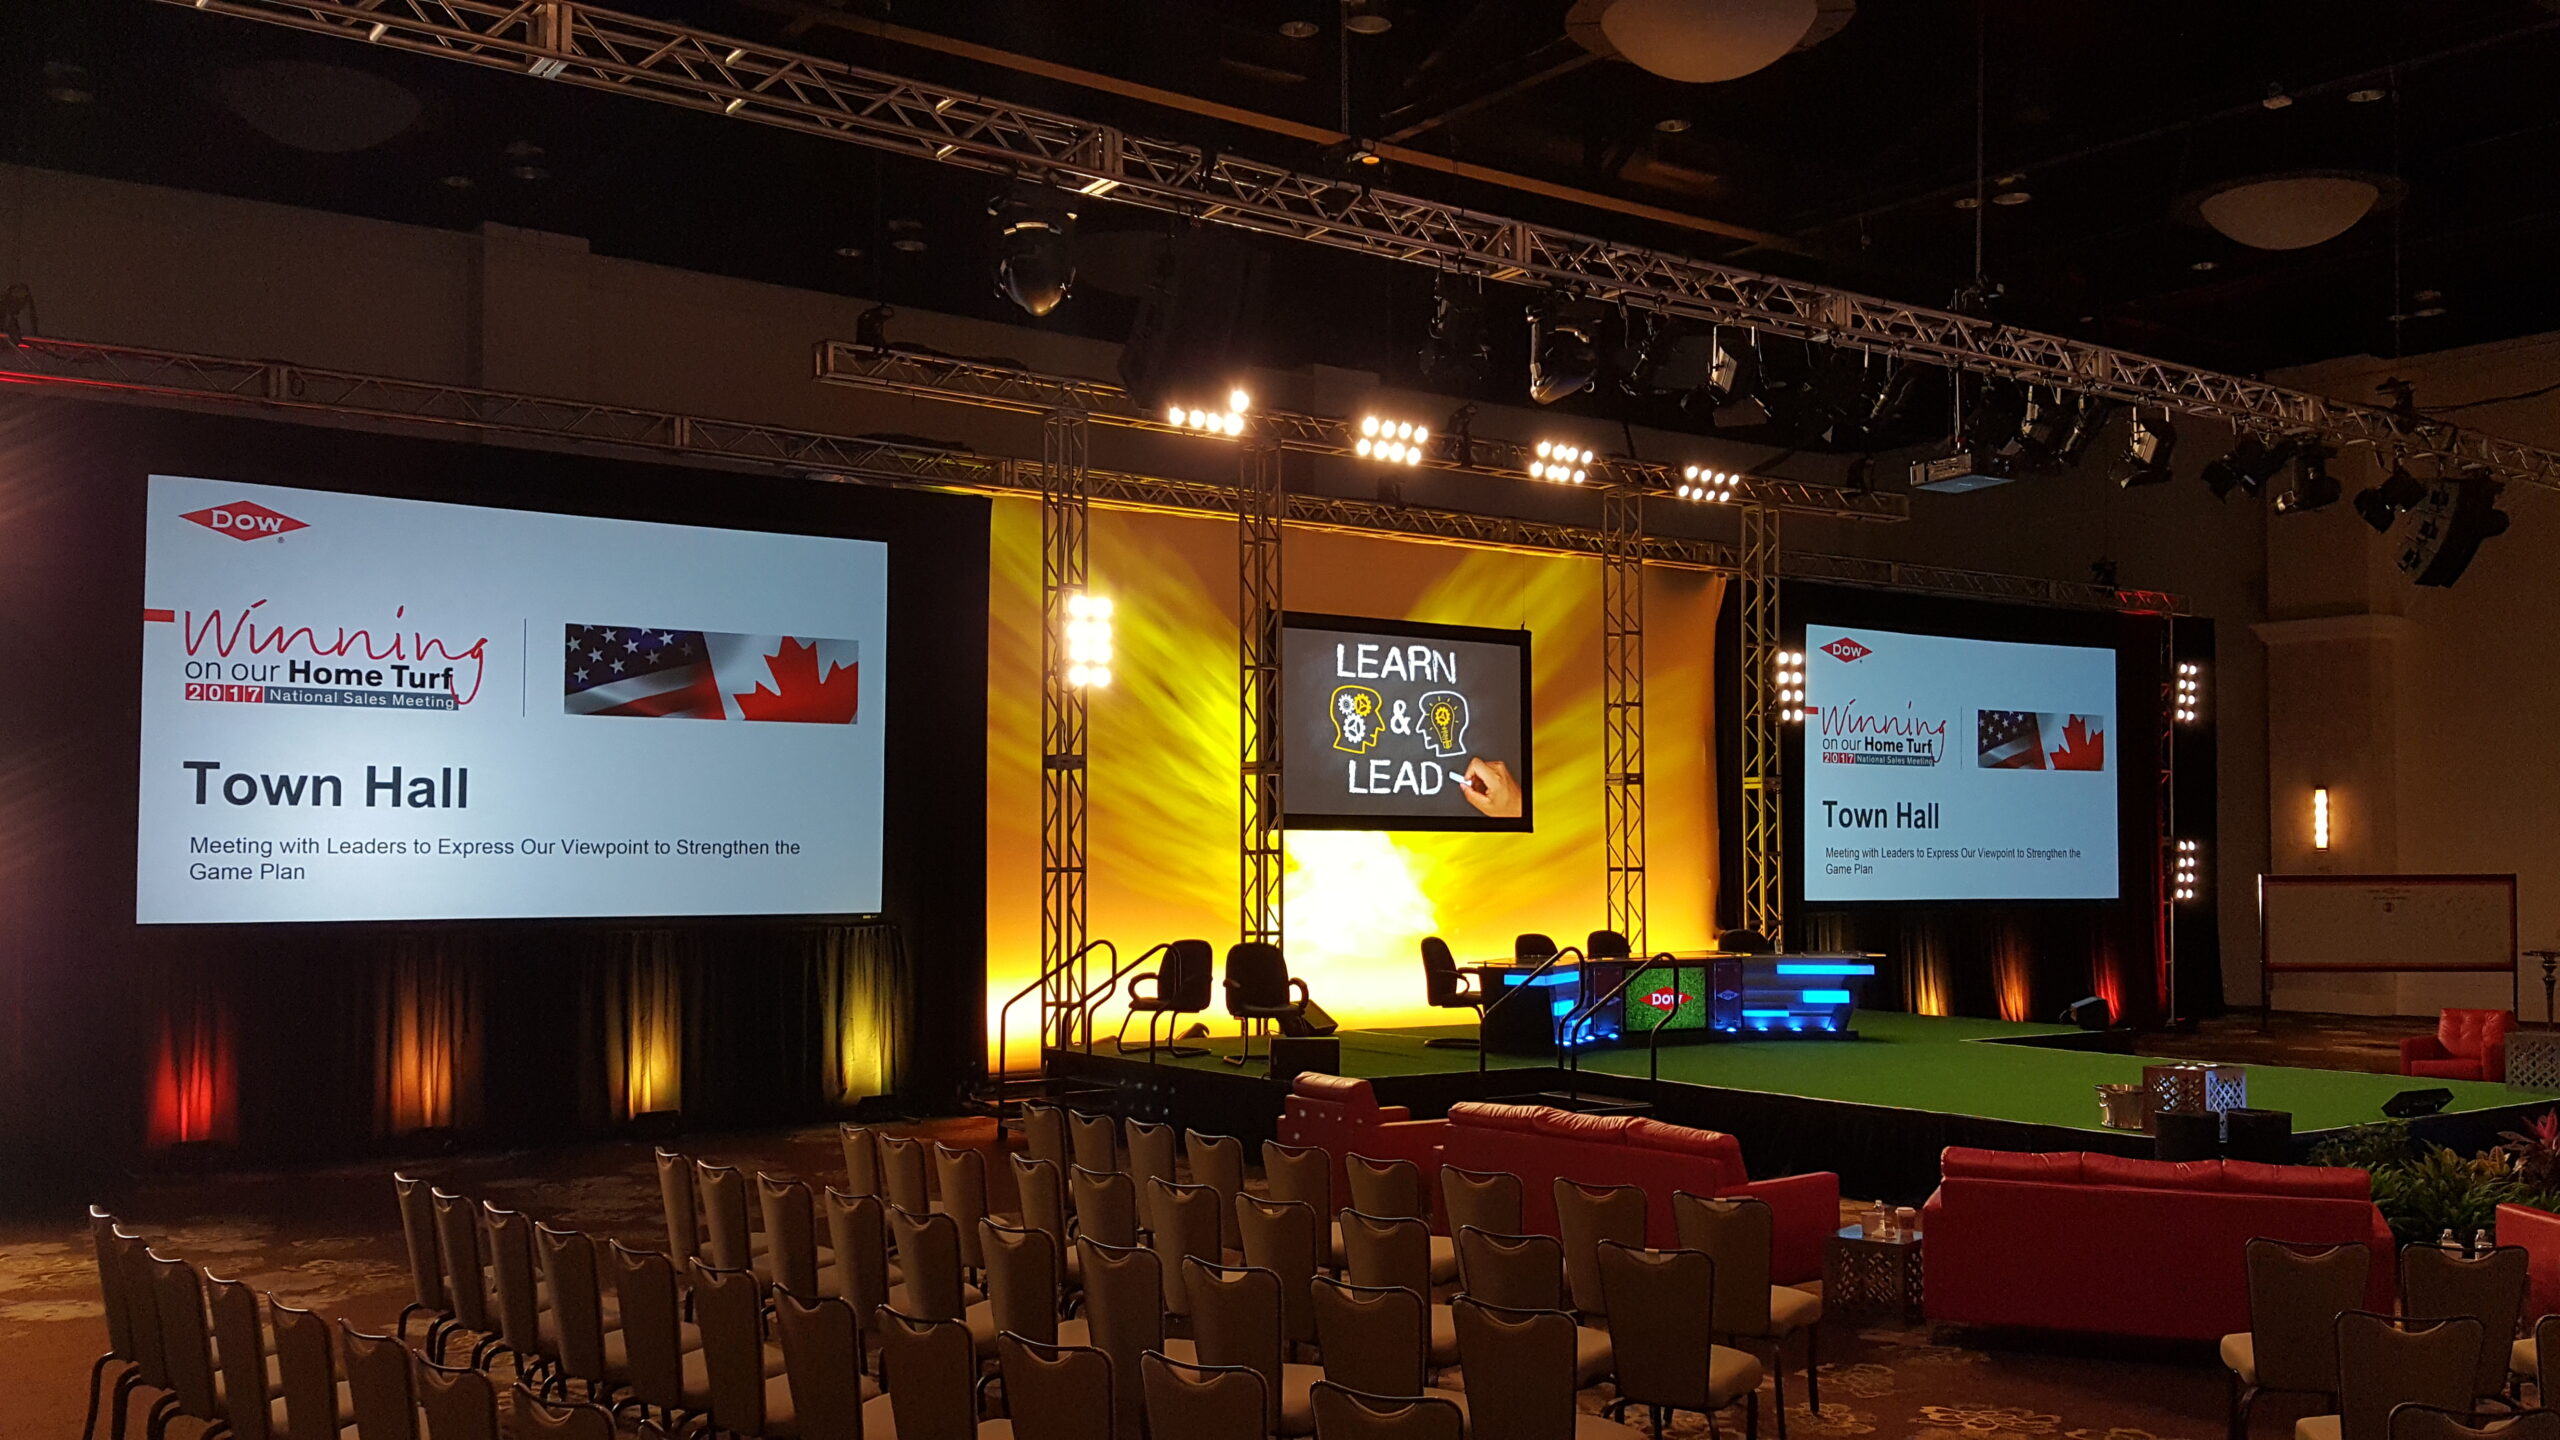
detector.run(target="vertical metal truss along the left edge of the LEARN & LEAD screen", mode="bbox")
[1234,443,1288,945]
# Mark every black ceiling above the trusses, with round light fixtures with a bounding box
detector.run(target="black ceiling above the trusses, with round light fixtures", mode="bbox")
[0,0,2560,402]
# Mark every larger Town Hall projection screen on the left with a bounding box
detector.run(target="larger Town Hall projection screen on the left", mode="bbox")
[136,474,888,925]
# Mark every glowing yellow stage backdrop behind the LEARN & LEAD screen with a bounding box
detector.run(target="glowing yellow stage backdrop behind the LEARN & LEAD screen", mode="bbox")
[986,502,1720,1068]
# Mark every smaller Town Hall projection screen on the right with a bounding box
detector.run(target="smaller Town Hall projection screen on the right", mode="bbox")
[1797,625,2117,902]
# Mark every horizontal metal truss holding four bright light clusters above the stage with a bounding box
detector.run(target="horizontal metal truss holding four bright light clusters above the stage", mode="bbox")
[814,341,1910,520]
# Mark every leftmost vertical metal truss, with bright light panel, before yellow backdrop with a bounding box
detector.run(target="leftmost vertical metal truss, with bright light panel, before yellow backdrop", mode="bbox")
[1039,410,1091,1048]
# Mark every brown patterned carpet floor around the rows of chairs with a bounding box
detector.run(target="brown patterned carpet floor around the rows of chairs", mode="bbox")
[0,1120,2294,1440]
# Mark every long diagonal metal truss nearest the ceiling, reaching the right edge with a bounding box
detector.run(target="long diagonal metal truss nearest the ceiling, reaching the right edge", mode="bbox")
[164,0,2560,487]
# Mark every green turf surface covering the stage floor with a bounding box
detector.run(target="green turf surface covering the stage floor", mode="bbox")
[1132,1010,2545,1133]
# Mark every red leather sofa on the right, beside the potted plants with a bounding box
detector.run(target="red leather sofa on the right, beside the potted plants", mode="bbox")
[1920,1148,2396,1340]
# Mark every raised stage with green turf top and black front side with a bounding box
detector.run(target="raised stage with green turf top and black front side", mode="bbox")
[1050,1012,2560,1202]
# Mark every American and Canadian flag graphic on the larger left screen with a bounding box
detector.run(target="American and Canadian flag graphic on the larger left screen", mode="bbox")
[561,625,860,725]
